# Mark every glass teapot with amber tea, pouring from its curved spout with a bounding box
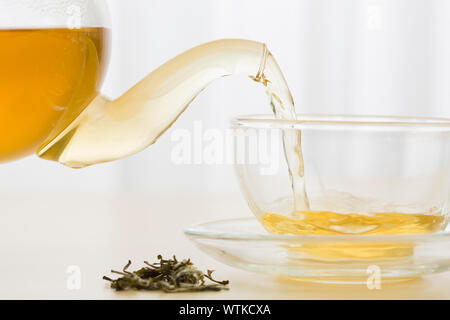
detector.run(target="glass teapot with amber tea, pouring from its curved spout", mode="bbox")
[0,0,293,168]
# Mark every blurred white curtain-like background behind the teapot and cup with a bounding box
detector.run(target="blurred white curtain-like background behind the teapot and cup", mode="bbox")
[0,0,450,195]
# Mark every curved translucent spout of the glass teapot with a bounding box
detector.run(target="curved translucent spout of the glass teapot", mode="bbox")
[38,39,278,168]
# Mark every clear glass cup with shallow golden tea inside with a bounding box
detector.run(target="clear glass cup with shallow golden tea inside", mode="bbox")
[232,115,450,235]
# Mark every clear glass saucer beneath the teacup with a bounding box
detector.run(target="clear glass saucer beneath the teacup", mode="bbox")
[185,218,450,284]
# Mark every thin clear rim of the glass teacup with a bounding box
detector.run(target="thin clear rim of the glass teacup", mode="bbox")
[231,114,450,131]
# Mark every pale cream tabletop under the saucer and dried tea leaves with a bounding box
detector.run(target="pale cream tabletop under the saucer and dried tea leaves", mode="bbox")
[0,194,450,300]
